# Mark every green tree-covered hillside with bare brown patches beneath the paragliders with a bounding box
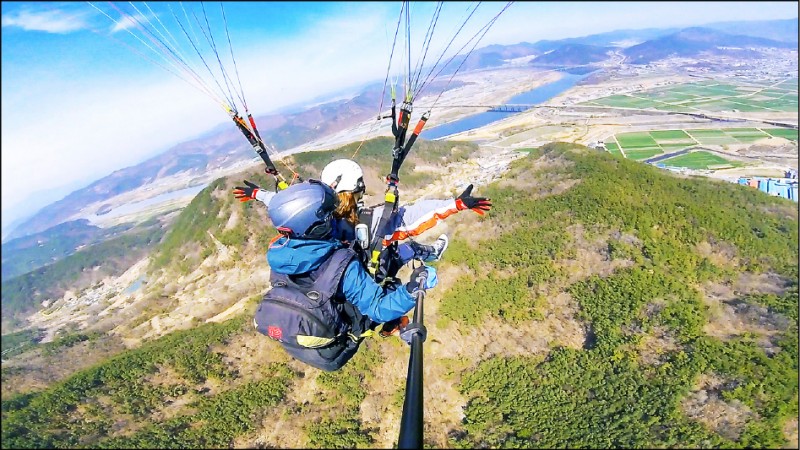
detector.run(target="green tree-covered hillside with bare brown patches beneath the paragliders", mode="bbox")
[2,140,798,448]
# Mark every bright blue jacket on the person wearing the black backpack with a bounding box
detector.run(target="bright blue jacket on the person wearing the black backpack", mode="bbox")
[267,237,416,322]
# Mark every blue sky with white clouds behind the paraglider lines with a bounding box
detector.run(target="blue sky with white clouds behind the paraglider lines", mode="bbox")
[1,2,797,236]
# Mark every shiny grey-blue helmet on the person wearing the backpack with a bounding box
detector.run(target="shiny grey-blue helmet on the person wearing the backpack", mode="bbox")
[269,180,339,239]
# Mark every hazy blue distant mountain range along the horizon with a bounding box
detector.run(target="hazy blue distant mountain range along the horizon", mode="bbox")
[3,19,798,243]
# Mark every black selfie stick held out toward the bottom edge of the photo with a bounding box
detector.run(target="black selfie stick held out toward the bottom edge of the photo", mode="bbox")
[397,280,427,449]
